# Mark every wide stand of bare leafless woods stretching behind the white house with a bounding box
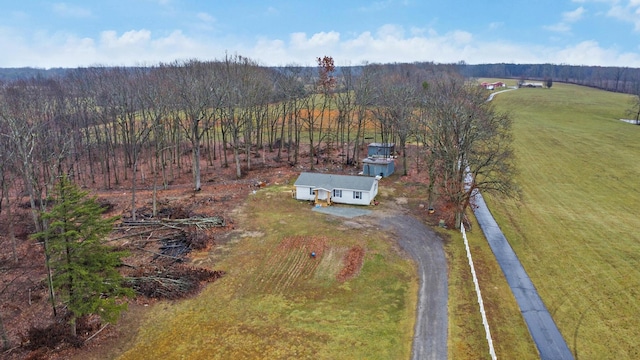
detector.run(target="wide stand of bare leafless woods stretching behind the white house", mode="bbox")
[0,55,509,231]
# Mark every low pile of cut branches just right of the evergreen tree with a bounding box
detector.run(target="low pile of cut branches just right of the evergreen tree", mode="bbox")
[126,264,225,300]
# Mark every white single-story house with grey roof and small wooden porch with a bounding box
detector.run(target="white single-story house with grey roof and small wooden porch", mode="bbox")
[293,172,380,205]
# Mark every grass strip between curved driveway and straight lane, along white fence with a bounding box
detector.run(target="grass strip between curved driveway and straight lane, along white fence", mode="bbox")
[394,182,539,359]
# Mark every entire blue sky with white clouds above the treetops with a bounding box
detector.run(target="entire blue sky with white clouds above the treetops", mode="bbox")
[0,0,640,68]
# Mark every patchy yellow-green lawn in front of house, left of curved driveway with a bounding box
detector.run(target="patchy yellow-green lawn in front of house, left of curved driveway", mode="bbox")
[121,185,418,359]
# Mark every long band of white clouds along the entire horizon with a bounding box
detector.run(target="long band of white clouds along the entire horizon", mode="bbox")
[0,25,640,68]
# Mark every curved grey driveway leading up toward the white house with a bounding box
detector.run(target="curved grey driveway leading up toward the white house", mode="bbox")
[380,214,448,360]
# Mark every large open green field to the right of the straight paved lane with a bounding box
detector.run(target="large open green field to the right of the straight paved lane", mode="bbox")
[487,83,640,359]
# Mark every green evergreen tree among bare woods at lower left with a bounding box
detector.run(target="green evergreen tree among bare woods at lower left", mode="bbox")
[34,177,133,336]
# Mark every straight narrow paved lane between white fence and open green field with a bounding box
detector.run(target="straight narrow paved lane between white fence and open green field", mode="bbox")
[473,193,573,360]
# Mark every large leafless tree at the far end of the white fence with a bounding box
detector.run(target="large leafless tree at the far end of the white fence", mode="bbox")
[427,74,519,228]
